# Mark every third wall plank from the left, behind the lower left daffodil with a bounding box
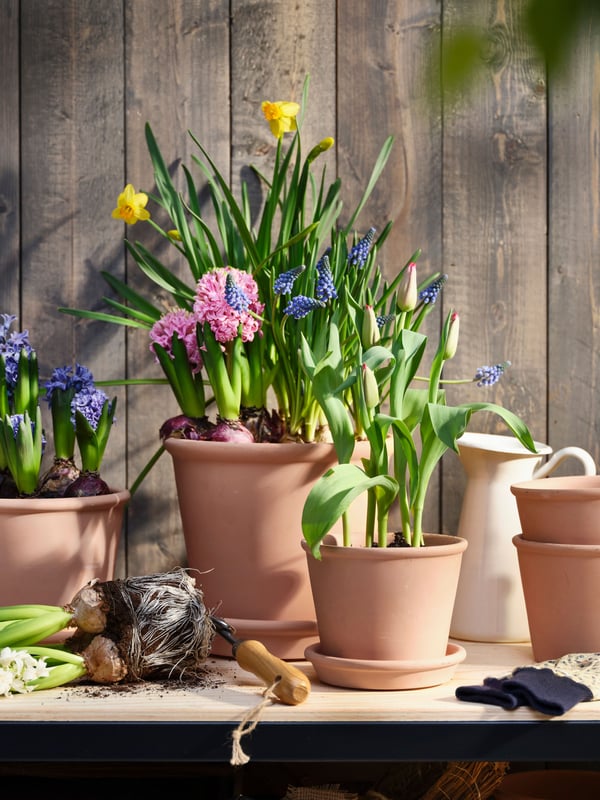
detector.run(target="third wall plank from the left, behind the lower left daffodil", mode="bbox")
[123,0,229,574]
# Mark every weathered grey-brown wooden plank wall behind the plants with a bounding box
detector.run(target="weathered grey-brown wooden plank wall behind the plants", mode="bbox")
[0,0,600,573]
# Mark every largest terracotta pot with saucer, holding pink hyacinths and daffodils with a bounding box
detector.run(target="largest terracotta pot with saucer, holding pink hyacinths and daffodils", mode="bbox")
[165,439,366,659]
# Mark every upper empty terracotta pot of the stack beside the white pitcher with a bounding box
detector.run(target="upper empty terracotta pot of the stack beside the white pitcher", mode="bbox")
[510,475,600,545]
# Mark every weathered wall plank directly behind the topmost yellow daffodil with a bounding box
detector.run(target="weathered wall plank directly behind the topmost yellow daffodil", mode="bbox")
[231,0,336,231]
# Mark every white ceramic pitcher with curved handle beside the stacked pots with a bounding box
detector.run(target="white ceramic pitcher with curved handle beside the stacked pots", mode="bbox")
[450,433,596,642]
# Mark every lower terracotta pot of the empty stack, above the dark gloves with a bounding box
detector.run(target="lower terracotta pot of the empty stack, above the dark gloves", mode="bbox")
[513,535,600,661]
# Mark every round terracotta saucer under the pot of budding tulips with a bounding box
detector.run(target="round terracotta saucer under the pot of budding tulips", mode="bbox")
[304,643,467,690]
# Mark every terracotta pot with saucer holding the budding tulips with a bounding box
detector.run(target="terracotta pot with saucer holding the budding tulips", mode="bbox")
[302,534,467,689]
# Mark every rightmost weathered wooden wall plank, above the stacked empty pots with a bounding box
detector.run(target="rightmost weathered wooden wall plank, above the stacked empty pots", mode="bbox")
[548,17,600,472]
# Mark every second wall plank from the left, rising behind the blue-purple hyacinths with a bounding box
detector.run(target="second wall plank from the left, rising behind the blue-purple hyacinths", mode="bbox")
[20,0,126,536]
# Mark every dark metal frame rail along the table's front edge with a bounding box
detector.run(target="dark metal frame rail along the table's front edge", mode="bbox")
[0,719,600,764]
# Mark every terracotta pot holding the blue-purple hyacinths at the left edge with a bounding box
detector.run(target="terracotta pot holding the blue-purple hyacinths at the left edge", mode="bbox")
[0,491,130,606]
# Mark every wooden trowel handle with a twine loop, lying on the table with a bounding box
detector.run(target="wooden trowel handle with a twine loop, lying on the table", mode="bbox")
[233,639,310,706]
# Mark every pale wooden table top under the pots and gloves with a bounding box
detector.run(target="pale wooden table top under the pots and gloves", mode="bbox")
[0,642,600,760]
